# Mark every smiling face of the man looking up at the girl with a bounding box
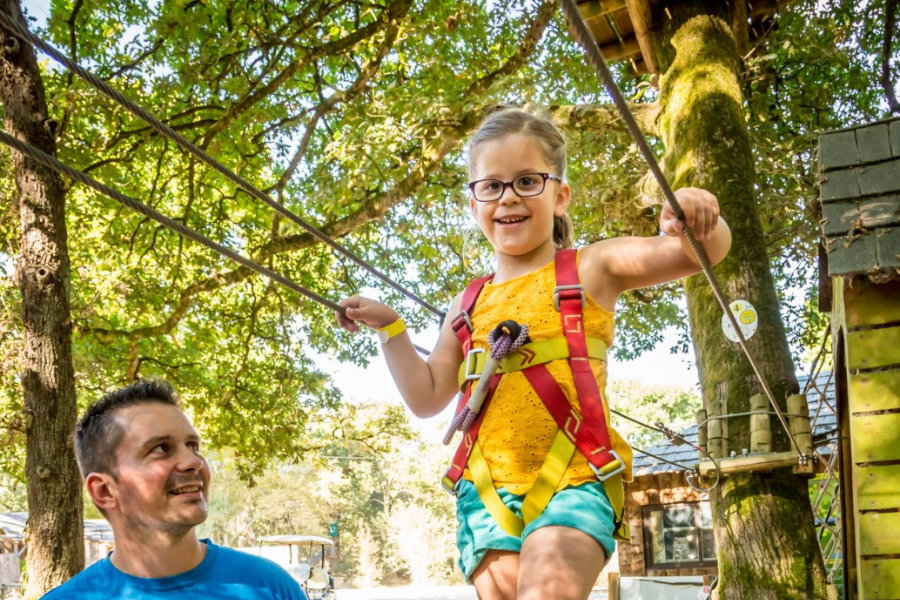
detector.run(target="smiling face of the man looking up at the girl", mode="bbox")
[108,402,210,537]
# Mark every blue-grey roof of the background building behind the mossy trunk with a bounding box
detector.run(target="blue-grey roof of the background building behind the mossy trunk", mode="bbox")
[634,371,837,477]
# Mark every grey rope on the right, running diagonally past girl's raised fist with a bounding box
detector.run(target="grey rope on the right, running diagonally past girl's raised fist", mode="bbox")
[559,0,803,455]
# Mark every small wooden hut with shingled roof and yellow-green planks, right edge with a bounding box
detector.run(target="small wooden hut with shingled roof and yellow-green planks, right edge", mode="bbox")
[819,119,900,600]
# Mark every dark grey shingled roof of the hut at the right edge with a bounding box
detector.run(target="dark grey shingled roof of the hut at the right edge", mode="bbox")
[819,118,900,282]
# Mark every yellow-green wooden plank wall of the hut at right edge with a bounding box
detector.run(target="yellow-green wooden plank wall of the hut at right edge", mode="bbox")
[836,280,900,600]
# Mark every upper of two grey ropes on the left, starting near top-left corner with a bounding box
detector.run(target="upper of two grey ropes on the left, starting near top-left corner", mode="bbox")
[0,10,441,316]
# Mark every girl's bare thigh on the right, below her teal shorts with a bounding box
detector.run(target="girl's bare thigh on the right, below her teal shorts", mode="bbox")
[517,526,606,600]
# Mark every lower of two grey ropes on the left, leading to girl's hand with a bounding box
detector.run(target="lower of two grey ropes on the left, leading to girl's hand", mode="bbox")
[0,130,429,355]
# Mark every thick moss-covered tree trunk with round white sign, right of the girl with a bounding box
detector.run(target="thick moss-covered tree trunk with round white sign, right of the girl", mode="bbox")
[657,0,827,600]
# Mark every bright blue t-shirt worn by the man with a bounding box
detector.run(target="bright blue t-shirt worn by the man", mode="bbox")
[43,540,307,600]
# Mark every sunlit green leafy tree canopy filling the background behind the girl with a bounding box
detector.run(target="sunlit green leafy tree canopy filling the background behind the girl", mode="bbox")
[0,0,900,477]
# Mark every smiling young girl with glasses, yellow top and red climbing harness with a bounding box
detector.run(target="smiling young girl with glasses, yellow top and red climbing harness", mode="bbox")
[338,110,731,600]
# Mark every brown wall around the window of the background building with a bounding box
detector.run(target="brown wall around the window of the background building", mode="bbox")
[618,472,717,577]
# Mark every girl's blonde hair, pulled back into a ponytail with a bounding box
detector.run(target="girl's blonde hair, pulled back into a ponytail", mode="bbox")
[469,109,574,250]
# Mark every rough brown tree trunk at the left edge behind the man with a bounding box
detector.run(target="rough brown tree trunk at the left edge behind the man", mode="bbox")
[0,0,84,598]
